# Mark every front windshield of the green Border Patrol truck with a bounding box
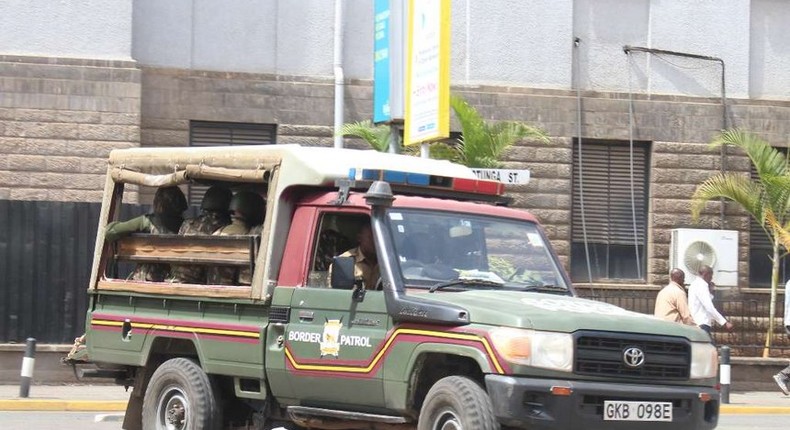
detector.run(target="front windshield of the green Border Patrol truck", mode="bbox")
[388,208,568,290]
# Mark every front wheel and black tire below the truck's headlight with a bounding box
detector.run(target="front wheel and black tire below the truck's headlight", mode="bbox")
[417,376,499,430]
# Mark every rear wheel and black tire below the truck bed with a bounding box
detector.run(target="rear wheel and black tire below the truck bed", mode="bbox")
[143,358,222,430]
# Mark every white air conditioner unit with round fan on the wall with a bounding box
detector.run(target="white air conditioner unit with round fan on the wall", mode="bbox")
[669,228,738,287]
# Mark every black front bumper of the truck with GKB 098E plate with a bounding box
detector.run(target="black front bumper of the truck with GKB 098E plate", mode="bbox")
[485,375,719,430]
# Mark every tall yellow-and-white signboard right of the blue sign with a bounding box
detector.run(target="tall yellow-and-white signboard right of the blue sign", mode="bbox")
[403,0,450,145]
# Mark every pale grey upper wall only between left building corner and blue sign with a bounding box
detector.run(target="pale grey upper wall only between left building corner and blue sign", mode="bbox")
[133,0,373,78]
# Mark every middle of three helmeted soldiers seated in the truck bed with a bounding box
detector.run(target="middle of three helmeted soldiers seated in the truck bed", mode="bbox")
[168,185,233,284]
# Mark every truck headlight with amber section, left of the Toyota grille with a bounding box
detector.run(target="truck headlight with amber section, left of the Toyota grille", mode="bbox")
[491,327,573,372]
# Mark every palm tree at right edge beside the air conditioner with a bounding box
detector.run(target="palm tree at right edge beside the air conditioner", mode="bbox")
[691,129,790,357]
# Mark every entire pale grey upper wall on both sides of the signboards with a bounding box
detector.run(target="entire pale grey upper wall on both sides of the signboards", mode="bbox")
[133,0,790,100]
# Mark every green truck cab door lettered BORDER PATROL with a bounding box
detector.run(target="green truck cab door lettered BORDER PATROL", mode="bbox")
[284,212,391,410]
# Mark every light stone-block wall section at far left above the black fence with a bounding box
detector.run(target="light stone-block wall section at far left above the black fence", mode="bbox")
[0,55,140,201]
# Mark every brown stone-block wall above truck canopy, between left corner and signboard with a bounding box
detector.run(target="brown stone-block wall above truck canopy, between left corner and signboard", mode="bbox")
[141,68,372,152]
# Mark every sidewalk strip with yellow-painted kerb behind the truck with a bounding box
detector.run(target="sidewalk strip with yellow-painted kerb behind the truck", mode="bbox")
[0,385,790,415]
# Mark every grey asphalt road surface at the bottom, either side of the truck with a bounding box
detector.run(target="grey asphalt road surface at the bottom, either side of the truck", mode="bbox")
[0,412,790,430]
